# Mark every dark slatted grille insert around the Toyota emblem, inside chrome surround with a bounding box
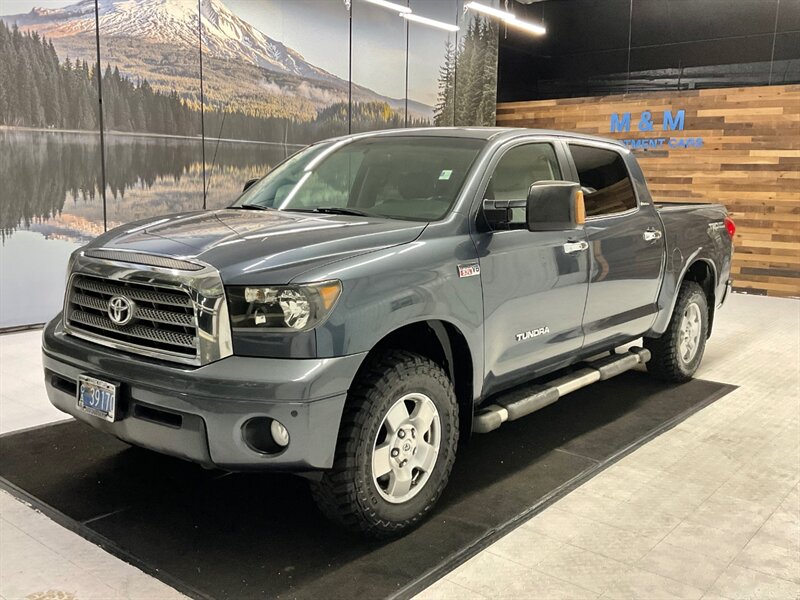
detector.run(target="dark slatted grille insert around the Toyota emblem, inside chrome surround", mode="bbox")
[66,275,197,358]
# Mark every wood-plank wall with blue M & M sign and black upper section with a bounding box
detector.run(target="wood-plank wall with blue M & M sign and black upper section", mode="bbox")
[497,0,800,296]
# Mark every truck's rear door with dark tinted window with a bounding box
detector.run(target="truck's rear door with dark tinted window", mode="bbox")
[568,143,665,349]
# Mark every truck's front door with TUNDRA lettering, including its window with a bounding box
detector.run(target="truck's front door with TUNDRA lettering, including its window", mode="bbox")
[475,142,589,394]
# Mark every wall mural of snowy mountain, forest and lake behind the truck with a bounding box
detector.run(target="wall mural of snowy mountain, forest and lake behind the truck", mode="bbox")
[0,0,497,328]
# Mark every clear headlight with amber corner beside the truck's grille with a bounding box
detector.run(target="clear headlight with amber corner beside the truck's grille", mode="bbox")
[226,281,342,331]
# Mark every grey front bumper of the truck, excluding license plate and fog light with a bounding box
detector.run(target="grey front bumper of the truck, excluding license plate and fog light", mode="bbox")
[42,316,365,472]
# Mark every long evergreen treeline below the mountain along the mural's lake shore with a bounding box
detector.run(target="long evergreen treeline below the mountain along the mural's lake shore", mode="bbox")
[0,20,430,144]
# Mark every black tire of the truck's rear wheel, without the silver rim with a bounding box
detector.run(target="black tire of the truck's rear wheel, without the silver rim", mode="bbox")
[644,281,708,382]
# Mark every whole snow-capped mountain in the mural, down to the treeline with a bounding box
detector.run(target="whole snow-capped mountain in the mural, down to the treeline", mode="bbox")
[0,0,433,119]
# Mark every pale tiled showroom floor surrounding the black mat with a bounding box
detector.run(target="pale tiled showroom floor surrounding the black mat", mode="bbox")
[0,295,800,600]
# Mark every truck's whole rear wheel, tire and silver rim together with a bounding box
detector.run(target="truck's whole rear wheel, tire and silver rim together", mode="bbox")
[644,281,708,382]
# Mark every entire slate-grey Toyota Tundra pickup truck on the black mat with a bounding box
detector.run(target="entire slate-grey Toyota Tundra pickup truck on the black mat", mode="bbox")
[43,128,735,537]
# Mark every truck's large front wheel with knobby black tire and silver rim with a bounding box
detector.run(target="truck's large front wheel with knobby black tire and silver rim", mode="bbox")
[311,351,458,537]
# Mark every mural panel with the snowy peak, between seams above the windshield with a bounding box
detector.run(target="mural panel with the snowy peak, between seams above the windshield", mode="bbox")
[203,0,349,208]
